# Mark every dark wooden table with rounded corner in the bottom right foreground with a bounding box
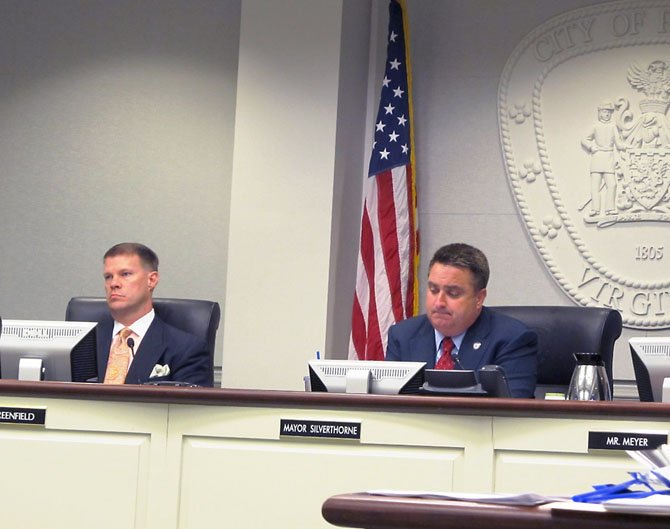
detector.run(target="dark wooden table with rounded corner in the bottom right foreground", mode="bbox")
[321,493,670,529]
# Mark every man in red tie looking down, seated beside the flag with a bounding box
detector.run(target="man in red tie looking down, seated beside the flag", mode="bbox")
[386,243,538,398]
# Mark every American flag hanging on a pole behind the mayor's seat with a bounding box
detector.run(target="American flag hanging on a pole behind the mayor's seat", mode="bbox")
[349,0,419,360]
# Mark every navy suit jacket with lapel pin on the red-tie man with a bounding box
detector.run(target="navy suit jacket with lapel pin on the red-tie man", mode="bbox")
[386,307,538,398]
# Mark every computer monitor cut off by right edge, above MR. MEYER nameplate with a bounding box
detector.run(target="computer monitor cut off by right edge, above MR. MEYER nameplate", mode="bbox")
[628,336,670,402]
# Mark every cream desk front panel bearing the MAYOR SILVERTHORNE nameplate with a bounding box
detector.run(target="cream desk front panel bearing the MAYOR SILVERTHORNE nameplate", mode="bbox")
[168,406,492,529]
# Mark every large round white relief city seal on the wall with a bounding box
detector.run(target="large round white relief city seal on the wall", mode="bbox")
[498,1,670,330]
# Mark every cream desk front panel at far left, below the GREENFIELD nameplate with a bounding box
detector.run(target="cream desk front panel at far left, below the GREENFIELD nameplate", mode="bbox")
[0,396,169,529]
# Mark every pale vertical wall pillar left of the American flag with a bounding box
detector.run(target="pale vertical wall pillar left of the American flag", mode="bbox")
[222,0,368,389]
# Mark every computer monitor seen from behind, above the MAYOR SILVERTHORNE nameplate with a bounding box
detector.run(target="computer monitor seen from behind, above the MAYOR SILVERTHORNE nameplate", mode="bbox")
[308,360,426,395]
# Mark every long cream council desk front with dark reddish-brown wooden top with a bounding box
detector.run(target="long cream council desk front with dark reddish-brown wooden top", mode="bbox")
[0,380,670,529]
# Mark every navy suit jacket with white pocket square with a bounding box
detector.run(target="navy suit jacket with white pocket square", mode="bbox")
[97,315,214,386]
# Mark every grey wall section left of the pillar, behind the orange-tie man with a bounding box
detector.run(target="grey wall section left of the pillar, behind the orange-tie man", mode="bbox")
[0,0,240,370]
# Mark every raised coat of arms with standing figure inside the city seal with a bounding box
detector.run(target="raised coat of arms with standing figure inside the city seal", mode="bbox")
[582,61,670,223]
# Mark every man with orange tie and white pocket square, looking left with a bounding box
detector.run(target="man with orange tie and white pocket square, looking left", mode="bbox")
[97,243,213,386]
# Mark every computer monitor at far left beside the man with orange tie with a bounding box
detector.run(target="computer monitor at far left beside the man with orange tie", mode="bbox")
[0,320,98,382]
